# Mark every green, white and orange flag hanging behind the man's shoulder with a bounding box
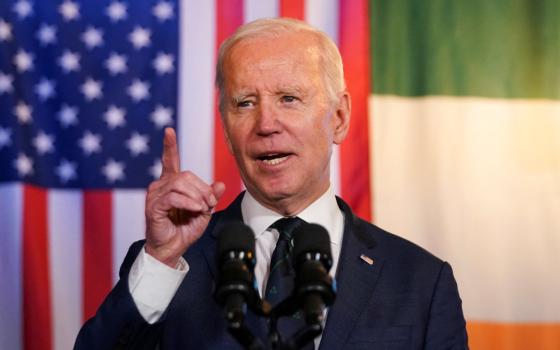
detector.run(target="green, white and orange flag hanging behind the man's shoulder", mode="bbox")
[369,0,560,349]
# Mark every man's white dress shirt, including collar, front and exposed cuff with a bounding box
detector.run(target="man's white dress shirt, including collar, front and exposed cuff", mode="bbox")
[128,187,344,347]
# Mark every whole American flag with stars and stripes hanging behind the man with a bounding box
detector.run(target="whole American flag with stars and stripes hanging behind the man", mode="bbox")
[0,0,370,350]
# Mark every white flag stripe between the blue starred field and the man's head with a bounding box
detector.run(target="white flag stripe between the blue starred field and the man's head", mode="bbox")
[177,0,216,182]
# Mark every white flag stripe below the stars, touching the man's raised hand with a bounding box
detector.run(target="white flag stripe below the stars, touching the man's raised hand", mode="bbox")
[113,190,146,282]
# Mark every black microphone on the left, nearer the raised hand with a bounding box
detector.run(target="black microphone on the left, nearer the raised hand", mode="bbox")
[214,222,259,328]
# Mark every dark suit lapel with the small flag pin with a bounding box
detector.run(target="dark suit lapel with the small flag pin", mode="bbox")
[321,199,383,349]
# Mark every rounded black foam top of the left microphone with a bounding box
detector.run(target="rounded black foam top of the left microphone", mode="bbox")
[217,222,255,258]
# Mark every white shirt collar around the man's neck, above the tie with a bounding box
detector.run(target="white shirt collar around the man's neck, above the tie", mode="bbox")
[241,186,342,244]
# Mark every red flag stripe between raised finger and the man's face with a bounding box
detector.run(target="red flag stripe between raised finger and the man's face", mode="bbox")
[214,0,243,210]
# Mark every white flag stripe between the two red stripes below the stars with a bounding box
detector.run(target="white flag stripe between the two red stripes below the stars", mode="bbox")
[47,190,82,349]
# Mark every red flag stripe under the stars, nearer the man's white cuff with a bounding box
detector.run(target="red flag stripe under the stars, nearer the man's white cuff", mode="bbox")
[83,191,113,320]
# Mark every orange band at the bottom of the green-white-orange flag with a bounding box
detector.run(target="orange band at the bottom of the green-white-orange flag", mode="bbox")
[467,321,560,350]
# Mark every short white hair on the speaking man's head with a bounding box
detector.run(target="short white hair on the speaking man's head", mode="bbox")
[216,18,346,112]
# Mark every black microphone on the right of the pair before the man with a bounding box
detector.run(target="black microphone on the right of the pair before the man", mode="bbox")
[293,223,336,325]
